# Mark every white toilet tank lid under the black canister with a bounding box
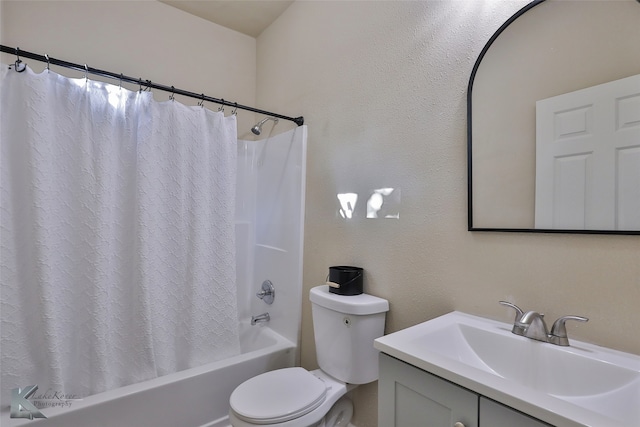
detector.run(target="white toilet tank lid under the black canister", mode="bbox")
[309,285,389,315]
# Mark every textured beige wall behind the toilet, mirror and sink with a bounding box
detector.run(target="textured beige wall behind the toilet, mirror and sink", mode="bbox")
[257,0,640,427]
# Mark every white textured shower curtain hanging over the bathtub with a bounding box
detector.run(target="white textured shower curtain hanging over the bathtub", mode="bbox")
[0,65,239,404]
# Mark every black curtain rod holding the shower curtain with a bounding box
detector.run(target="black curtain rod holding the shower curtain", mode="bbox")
[0,45,304,126]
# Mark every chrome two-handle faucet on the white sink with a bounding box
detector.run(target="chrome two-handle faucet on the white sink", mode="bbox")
[500,301,589,347]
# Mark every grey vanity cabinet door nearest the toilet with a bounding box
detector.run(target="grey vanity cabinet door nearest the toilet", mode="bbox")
[378,353,478,427]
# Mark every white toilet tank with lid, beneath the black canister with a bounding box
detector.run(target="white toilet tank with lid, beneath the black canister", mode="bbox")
[309,285,389,384]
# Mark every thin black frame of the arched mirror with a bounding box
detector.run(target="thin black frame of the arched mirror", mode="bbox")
[467,0,640,235]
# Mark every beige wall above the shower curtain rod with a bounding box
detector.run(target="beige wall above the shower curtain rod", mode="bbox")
[0,0,256,137]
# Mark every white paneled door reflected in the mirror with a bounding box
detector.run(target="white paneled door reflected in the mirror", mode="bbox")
[535,74,640,230]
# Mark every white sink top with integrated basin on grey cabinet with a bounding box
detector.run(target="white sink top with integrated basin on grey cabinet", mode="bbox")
[374,312,640,427]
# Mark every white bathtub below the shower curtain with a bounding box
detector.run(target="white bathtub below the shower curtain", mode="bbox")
[0,324,295,427]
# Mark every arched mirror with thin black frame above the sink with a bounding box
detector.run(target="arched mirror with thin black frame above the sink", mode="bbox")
[467,0,640,234]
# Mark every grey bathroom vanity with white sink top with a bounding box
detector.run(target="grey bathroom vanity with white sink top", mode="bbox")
[374,312,640,427]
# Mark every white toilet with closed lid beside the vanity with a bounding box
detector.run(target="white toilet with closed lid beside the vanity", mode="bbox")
[229,285,389,427]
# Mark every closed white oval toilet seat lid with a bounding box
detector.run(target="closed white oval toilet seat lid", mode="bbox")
[229,367,327,425]
